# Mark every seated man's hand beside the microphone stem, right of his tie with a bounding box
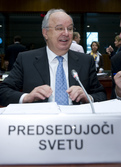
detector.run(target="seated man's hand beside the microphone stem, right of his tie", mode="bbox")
[67,86,89,103]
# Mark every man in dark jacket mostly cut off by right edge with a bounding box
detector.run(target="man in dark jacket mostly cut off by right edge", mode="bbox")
[111,15,121,100]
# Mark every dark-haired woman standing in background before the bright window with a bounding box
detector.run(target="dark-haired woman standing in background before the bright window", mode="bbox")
[89,41,104,73]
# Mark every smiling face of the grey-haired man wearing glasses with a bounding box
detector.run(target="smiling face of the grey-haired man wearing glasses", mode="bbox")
[43,12,73,55]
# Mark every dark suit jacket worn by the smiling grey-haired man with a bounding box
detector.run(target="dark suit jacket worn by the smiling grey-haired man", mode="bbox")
[0,47,106,106]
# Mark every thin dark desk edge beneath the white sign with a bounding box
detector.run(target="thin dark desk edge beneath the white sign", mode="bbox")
[0,163,121,167]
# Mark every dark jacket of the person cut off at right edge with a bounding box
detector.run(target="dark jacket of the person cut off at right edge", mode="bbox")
[111,51,121,99]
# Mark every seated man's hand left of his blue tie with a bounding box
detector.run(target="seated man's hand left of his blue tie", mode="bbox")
[23,85,52,103]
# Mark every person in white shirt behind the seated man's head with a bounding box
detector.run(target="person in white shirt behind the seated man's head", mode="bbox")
[70,32,84,53]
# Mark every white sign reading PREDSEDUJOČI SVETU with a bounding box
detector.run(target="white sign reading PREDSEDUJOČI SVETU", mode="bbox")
[0,113,121,164]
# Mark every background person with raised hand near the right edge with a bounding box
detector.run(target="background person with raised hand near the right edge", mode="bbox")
[106,35,121,58]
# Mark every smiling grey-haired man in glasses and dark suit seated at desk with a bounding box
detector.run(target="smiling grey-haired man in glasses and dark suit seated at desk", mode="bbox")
[0,9,106,106]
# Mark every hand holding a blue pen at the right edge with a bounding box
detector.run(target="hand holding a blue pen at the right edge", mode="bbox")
[114,71,121,97]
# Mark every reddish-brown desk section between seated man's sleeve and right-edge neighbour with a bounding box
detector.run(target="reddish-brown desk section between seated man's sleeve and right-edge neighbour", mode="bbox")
[98,76,112,100]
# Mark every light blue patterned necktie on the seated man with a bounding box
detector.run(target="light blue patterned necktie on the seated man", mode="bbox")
[55,56,68,105]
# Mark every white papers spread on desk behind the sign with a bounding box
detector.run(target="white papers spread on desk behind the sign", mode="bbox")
[0,99,121,114]
